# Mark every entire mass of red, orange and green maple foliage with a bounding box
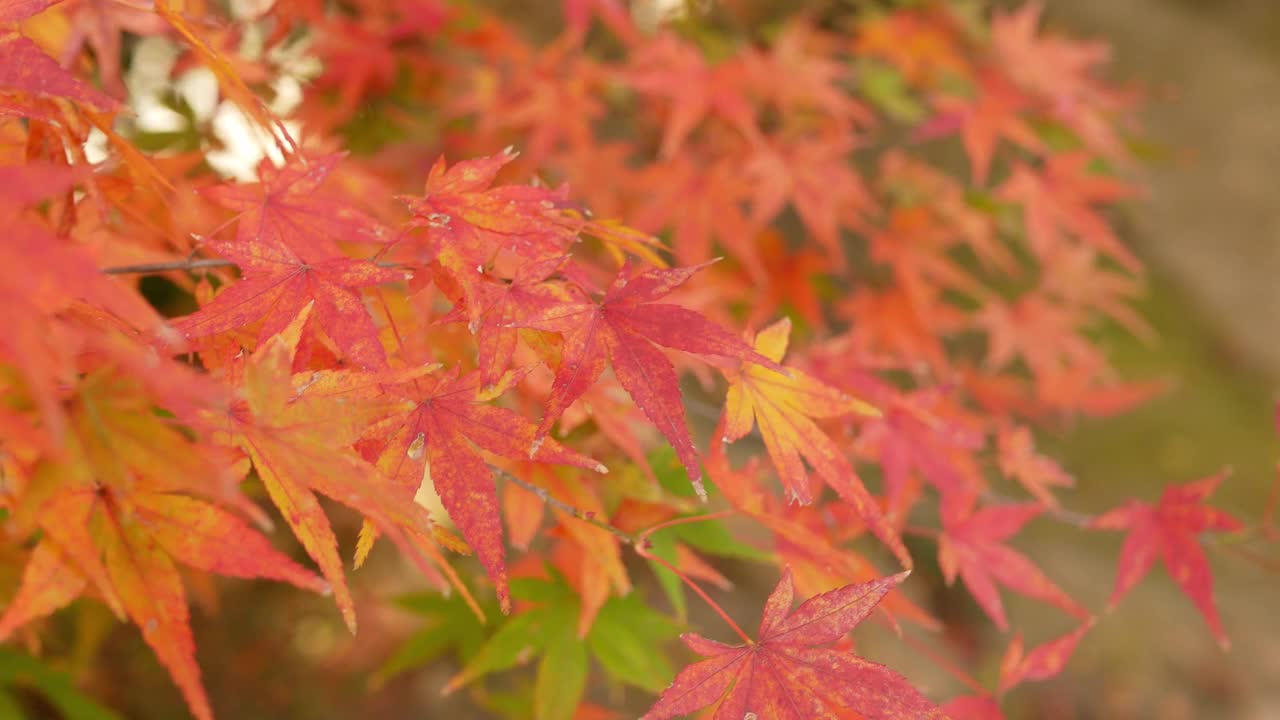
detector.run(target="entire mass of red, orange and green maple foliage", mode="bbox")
[0,0,1264,720]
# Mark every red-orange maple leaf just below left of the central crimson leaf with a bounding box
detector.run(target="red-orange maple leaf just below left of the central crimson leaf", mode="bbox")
[355,368,608,610]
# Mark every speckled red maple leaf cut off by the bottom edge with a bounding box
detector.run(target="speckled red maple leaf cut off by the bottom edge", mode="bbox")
[641,570,943,720]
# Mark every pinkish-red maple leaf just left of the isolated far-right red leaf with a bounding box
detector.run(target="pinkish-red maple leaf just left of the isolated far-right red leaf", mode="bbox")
[938,503,1088,630]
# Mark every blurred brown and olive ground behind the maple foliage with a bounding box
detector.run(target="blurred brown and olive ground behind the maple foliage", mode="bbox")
[12,0,1280,720]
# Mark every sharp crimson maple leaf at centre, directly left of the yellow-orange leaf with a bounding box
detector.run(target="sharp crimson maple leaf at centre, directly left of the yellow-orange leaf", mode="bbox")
[525,265,785,488]
